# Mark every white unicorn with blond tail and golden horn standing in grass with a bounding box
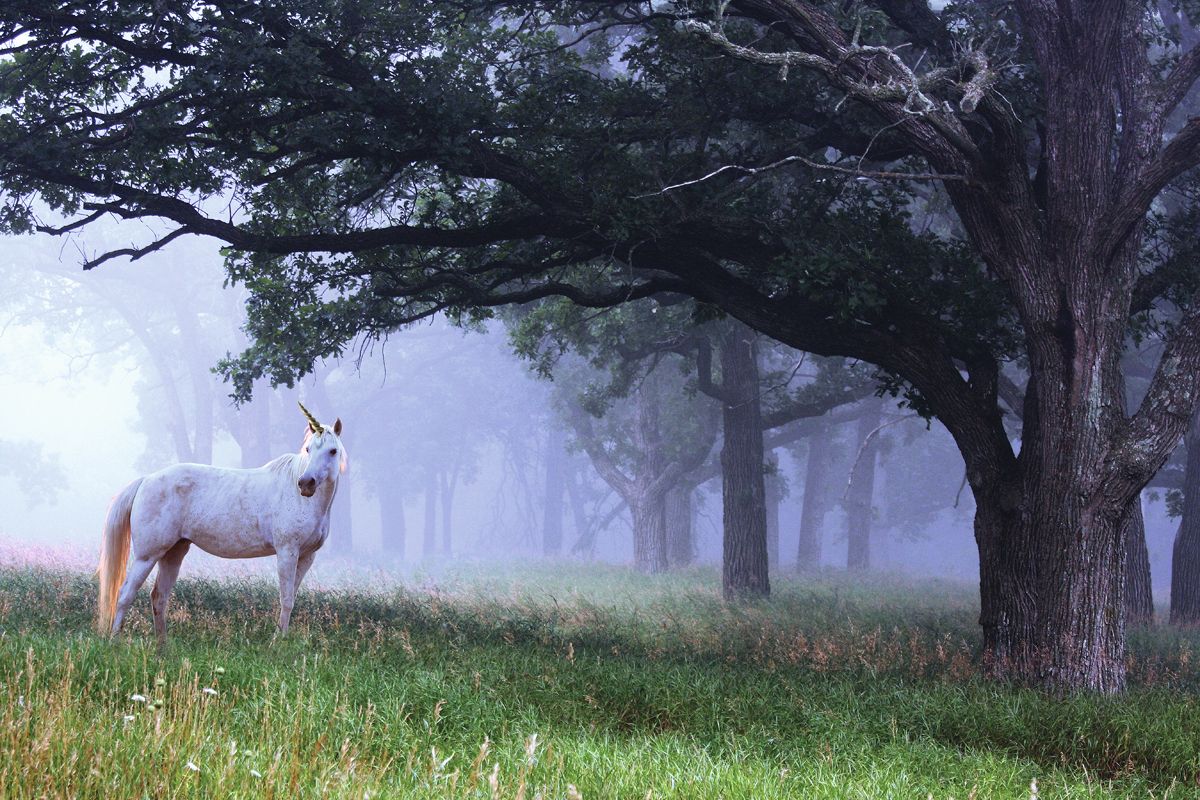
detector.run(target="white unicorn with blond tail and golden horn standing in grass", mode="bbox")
[96,405,347,640]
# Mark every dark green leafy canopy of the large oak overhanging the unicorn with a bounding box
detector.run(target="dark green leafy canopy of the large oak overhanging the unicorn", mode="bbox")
[0,0,1014,407]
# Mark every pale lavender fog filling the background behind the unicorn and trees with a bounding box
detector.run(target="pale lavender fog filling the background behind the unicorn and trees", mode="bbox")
[0,228,1176,603]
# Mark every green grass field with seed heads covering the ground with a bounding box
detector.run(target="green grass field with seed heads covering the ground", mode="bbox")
[0,556,1200,800]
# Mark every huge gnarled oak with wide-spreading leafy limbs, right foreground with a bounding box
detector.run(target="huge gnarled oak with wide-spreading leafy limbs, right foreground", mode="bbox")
[11,0,1200,691]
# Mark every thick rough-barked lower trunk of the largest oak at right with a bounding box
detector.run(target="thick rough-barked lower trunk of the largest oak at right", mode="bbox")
[1018,338,1141,692]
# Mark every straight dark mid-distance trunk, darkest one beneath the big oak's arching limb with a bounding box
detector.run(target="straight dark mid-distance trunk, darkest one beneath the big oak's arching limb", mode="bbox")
[721,325,770,599]
